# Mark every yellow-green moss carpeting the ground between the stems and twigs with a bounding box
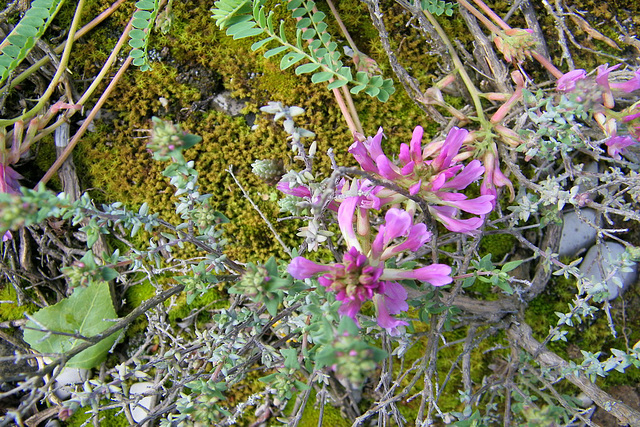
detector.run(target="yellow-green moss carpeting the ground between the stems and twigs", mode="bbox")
[8,0,640,426]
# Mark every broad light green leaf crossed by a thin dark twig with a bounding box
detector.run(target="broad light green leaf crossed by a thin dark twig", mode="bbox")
[24,282,119,369]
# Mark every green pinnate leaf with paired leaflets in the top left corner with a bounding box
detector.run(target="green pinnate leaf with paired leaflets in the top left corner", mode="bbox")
[0,0,64,84]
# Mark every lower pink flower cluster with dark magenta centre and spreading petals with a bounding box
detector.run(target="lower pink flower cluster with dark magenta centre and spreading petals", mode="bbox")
[288,209,452,335]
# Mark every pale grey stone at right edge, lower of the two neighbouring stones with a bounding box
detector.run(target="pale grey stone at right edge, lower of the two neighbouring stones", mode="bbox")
[580,242,638,301]
